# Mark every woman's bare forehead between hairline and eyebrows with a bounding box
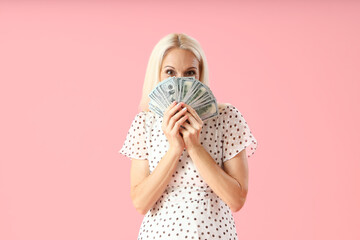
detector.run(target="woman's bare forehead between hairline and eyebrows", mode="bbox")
[162,48,199,67]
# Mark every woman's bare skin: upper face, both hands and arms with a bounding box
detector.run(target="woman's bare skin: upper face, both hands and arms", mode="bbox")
[130,48,249,215]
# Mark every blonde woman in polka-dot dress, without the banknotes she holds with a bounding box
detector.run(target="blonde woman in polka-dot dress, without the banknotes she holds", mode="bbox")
[119,33,257,240]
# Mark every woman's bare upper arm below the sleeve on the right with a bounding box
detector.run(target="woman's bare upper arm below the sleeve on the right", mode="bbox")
[224,148,249,196]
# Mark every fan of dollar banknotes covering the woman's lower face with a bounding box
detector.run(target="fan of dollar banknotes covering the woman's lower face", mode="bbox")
[149,77,219,121]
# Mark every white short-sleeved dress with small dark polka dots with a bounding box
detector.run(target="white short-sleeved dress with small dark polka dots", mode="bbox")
[119,103,257,240]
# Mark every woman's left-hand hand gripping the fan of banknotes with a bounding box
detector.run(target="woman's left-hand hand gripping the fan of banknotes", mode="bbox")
[161,101,188,154]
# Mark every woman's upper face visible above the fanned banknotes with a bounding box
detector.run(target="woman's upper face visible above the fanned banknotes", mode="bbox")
[160,48,200,82]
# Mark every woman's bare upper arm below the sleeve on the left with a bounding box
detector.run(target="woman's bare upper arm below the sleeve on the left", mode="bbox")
[130,158,150,199]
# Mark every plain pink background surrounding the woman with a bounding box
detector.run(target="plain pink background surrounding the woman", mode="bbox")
[0,1,360,240]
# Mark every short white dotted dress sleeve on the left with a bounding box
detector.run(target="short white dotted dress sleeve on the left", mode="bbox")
[119,111,148,160]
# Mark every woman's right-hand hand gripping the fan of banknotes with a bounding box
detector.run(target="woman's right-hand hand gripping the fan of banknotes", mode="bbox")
[180,103,203,151]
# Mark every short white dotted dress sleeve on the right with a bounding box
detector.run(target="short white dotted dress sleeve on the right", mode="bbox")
[221,104,258,162]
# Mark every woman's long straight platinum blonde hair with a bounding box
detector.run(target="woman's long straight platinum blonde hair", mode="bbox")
[139,33,209,111]
